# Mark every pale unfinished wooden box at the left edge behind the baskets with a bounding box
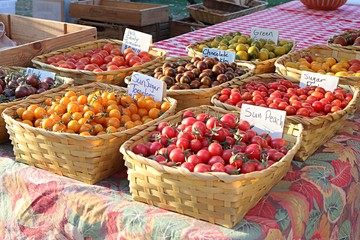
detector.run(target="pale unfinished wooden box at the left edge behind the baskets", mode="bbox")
[0,14,96,67]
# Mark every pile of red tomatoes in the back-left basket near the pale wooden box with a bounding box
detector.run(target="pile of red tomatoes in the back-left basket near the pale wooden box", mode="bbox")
[46,43,152,72]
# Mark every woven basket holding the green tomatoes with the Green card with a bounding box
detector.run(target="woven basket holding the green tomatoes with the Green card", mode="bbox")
[186,37,296,74]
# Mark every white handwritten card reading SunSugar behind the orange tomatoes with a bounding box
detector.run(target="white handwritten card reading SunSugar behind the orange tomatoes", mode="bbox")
[128,72,166,102]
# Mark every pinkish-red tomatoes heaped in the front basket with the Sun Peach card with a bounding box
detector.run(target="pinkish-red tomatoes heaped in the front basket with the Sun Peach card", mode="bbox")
[132,110,288,175]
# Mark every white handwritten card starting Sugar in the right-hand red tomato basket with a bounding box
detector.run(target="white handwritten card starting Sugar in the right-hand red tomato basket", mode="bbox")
[299,71,339,91]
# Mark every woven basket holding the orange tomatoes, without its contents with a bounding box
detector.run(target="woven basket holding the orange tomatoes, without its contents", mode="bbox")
[2,83,176,184]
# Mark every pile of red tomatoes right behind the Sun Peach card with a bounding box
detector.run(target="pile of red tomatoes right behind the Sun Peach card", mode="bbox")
[216,79,353,117]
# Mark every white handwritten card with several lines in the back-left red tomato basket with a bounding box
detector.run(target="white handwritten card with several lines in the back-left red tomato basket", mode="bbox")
[121,28,152,54]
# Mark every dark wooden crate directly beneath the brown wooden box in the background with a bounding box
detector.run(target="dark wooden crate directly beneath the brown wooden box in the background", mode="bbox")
[75,19,170,42]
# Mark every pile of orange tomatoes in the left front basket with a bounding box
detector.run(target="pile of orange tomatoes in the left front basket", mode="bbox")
[14,90,171,136]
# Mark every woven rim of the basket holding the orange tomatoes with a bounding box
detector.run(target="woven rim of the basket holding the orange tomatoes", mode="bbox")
[1,82,177,140]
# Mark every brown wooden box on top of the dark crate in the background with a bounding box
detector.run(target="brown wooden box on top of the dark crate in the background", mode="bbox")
[69,0,169,26]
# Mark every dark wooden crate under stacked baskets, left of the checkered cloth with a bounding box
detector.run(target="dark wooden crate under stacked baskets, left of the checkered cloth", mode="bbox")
[170,17,210,37]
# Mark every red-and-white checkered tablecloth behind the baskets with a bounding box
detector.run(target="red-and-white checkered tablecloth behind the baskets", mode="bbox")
[154,1,360,57]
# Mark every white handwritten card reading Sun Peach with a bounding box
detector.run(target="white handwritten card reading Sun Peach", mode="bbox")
[240,104,286,138]
